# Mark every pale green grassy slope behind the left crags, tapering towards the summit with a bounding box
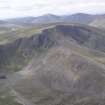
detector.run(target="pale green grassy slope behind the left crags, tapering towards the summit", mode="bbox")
[0,23,57,45]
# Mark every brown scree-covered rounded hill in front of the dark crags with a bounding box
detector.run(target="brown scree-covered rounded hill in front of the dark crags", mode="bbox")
[11,47,105,105]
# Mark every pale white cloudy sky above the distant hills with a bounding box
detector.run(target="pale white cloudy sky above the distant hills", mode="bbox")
[0,0,105,19]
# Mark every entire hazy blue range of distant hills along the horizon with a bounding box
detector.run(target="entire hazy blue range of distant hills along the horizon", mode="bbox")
[7,13,105,25]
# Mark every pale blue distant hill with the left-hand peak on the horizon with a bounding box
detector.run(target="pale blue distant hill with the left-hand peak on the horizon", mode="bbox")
[7,14,60,25]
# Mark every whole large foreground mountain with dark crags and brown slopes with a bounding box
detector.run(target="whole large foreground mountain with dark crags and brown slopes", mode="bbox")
[0,23,105,105]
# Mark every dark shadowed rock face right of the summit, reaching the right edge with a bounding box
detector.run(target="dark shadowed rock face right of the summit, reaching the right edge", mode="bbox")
[56,25,105,51]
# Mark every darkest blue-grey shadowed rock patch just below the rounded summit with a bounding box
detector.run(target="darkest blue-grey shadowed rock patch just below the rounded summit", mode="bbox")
[56,26,91,44]
